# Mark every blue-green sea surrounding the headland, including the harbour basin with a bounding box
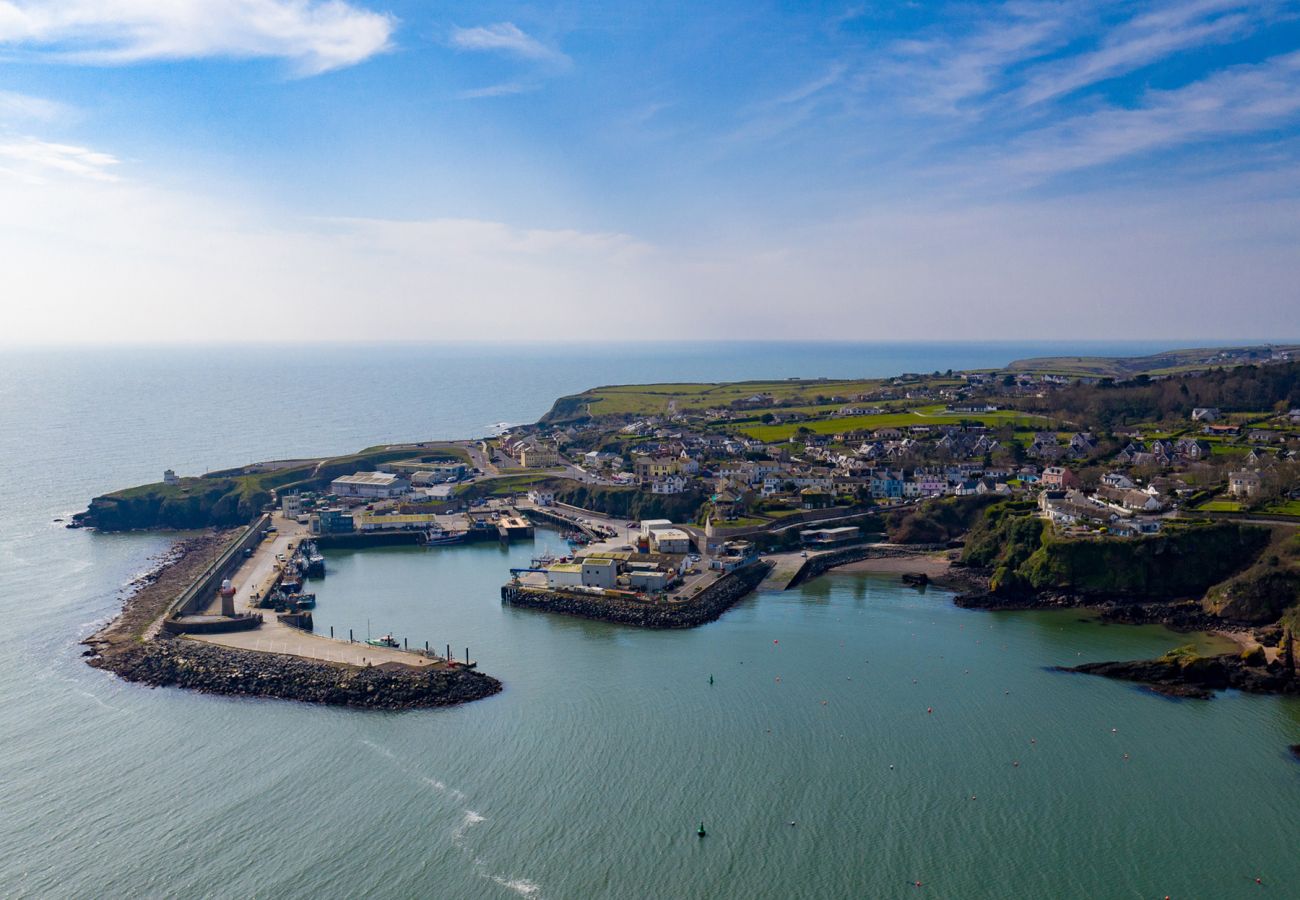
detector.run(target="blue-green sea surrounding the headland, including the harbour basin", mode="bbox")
[0,343,1300,900]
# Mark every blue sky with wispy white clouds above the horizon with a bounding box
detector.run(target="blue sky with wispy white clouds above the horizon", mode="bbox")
[0,0,1300,343]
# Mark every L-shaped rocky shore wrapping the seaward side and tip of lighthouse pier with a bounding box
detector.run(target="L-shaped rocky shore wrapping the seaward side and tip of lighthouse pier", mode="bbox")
[83,532,502,710]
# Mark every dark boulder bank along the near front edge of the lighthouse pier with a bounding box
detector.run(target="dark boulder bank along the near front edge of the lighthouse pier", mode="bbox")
[90,639,502,710]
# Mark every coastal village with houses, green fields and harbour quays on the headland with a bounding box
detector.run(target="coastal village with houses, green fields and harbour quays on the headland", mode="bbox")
[72,349,1300,712]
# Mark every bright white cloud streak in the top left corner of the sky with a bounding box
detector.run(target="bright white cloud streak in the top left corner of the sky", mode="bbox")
[0,0,395,74]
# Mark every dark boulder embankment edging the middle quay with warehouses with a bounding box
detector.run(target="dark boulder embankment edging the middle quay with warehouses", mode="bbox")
[501,563,771,628]
